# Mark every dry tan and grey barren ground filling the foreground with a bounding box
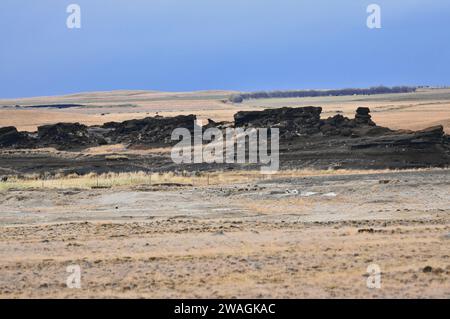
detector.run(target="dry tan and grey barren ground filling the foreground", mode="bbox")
[0,169,450,298]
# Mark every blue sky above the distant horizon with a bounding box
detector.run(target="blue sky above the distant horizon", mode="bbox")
[0,0,450,98]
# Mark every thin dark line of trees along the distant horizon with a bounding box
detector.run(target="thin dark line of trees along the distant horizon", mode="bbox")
[229,86,417,103]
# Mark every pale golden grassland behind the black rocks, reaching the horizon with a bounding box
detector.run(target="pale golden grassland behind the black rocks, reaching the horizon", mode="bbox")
[0,89,450,132]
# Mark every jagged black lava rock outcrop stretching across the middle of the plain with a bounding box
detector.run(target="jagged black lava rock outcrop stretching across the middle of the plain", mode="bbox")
[0,106,450,172]
